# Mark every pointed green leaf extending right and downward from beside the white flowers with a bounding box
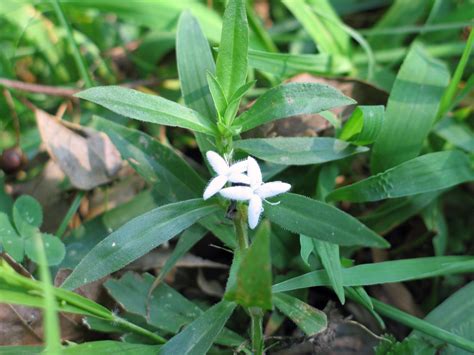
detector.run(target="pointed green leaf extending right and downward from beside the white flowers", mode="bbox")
[265,193,389,248]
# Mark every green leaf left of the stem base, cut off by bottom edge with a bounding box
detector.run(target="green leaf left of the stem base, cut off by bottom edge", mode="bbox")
[159,301,236,355]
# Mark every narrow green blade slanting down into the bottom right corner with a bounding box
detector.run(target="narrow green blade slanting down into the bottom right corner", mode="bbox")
[372,298,474,352]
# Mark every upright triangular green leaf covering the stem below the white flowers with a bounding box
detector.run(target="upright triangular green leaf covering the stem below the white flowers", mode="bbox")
[225,221,272,310]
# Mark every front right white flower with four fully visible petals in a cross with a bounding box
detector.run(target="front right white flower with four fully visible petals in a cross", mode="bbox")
[220,157,291,229]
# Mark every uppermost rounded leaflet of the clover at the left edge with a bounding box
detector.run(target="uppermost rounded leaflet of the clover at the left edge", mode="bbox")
[13,195,43,237]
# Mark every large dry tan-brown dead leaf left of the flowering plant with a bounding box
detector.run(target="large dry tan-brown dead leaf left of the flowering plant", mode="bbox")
[35,109,122,190]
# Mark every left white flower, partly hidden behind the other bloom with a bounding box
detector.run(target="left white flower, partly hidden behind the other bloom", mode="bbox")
[203,150,250,200]
